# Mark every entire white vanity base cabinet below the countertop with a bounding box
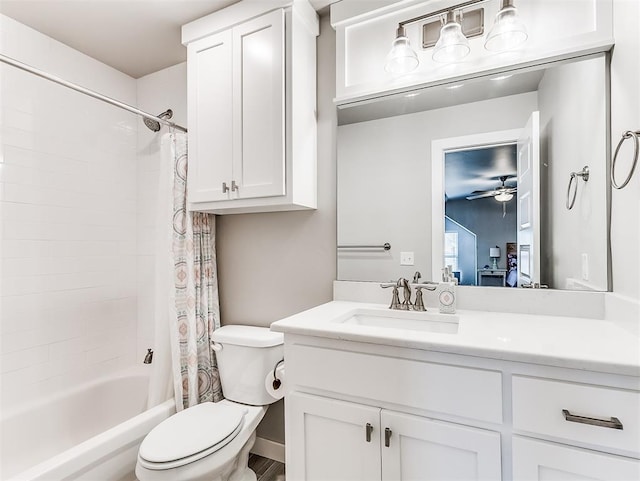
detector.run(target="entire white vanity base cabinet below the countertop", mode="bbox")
[276,332,640,481]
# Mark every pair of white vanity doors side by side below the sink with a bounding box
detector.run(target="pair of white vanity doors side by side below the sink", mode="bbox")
[287,393,501,481]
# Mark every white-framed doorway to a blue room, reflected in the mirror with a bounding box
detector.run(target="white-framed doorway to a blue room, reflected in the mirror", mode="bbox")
[431,129,522,286]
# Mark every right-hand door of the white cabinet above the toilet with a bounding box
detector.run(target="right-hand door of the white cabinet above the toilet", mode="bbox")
[232,10,285,199]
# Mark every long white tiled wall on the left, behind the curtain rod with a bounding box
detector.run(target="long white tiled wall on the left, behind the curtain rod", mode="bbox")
[0,16,143,409]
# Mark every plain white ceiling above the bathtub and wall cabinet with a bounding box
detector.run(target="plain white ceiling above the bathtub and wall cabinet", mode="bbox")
[0,0,335,78]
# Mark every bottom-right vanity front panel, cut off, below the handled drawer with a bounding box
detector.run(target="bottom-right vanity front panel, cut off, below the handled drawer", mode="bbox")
[513,436,640,481]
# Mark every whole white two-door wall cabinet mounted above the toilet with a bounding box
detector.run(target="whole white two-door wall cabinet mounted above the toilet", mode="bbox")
[183,1,318,214]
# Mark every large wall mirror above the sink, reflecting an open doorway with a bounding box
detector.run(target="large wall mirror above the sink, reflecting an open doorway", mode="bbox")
[337,54,609,291]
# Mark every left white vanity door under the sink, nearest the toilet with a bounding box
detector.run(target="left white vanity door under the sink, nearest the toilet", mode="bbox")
[286,393,380,481]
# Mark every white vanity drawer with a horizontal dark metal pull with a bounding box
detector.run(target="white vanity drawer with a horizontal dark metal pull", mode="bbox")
[513,376,640,454]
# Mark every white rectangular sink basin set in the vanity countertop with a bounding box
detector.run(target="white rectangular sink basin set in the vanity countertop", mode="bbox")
[333,308,459,334]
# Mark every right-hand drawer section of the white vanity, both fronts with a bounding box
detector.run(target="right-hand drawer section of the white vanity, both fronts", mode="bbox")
[512,375,640,481]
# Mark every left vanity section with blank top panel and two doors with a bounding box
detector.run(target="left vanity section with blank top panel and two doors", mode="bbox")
[285,336,502,481]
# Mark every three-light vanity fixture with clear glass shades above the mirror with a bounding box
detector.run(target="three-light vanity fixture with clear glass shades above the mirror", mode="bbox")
[385,0,527,75]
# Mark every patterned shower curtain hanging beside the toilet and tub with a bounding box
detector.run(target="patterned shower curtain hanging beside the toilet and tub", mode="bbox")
[149,133,223,411]
